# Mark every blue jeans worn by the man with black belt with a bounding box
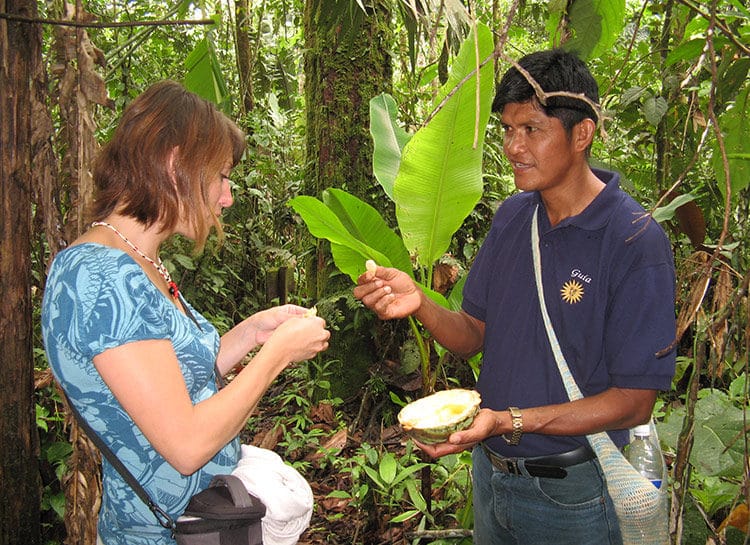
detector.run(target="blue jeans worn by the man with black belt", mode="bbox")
[472,445,622,545]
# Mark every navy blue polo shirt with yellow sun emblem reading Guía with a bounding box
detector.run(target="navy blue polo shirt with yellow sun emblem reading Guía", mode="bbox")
[463,170,675,457]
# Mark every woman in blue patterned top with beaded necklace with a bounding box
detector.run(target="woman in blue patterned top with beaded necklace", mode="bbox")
[42,81,330,545]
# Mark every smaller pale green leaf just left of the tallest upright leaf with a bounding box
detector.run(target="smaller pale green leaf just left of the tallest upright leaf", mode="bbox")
[370,93,411,200]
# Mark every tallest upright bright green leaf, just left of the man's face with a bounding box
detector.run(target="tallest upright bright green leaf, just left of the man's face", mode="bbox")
[393,25,494,267]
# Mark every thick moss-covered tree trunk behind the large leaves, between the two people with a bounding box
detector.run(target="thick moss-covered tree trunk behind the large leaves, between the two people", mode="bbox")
[303,0,392,397]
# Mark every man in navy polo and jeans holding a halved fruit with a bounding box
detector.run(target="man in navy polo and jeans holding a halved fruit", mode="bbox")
[354,50,675,545]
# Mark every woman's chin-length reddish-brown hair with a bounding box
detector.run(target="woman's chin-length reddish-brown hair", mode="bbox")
[92,81,245,250]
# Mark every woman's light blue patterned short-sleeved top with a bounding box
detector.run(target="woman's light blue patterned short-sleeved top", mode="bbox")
[42,243,240,545]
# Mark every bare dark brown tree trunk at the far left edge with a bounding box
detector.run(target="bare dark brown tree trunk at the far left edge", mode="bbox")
[0,0,41,545]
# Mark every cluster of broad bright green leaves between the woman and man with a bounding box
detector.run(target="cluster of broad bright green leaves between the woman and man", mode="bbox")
[289,20,492,285]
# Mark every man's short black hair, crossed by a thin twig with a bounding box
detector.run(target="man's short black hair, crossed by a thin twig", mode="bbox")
[492,49,599,133]
